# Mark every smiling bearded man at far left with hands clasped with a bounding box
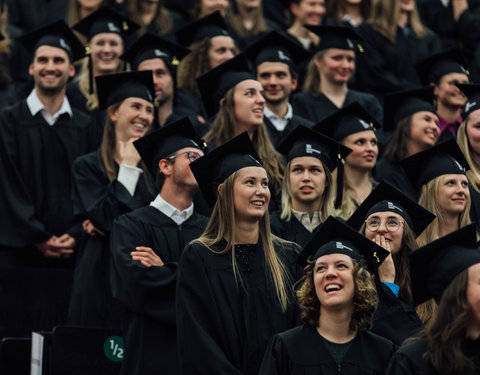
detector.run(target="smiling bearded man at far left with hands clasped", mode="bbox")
[0,21,94,337]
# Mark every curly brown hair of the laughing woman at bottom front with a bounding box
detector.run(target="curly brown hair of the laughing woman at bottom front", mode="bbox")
[297,259,378,331]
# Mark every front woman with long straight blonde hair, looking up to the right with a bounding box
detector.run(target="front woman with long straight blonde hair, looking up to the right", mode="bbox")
[177,133,301,375]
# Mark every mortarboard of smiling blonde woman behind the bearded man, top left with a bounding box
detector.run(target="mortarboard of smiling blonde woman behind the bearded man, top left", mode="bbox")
[73,6,140,40]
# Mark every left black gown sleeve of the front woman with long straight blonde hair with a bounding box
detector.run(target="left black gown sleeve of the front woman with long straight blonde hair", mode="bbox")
[176,245,242,375]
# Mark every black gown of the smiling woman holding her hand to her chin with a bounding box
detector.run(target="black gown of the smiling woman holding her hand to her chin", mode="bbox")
[68,151,155,327]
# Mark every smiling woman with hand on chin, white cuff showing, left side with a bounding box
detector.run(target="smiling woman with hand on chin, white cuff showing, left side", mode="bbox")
[69,72,155,327]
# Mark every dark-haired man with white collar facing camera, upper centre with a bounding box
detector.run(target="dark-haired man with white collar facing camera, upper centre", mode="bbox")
[245,31,313,147]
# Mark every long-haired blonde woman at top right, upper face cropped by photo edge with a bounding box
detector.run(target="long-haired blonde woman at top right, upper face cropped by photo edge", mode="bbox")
[355,0,441,96]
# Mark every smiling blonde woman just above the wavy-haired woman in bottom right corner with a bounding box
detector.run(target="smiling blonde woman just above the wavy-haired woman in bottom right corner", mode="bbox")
[400,139,471,323]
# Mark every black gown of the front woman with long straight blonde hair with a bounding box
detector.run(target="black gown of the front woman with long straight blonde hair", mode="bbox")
[177,239,303,375]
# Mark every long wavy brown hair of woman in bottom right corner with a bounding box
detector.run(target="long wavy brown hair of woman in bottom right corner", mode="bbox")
[422,269,475,375]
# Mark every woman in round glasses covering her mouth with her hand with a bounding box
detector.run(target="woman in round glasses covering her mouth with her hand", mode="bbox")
[347,182,434,345]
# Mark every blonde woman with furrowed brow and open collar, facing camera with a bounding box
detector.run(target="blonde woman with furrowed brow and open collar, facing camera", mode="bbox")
[271,125,351,246]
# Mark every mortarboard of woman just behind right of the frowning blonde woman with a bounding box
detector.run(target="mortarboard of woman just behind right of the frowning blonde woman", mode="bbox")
[313,102,380,142]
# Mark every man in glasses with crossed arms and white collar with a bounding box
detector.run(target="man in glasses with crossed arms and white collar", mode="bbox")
[110,118,208,375]
